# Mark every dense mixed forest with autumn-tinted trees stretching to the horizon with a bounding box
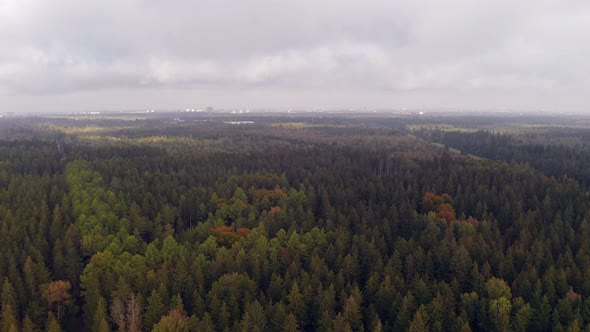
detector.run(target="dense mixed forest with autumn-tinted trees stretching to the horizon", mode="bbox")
[0,114,590,332]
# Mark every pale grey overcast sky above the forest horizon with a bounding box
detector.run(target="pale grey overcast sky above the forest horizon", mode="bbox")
[0,0,590,113]
